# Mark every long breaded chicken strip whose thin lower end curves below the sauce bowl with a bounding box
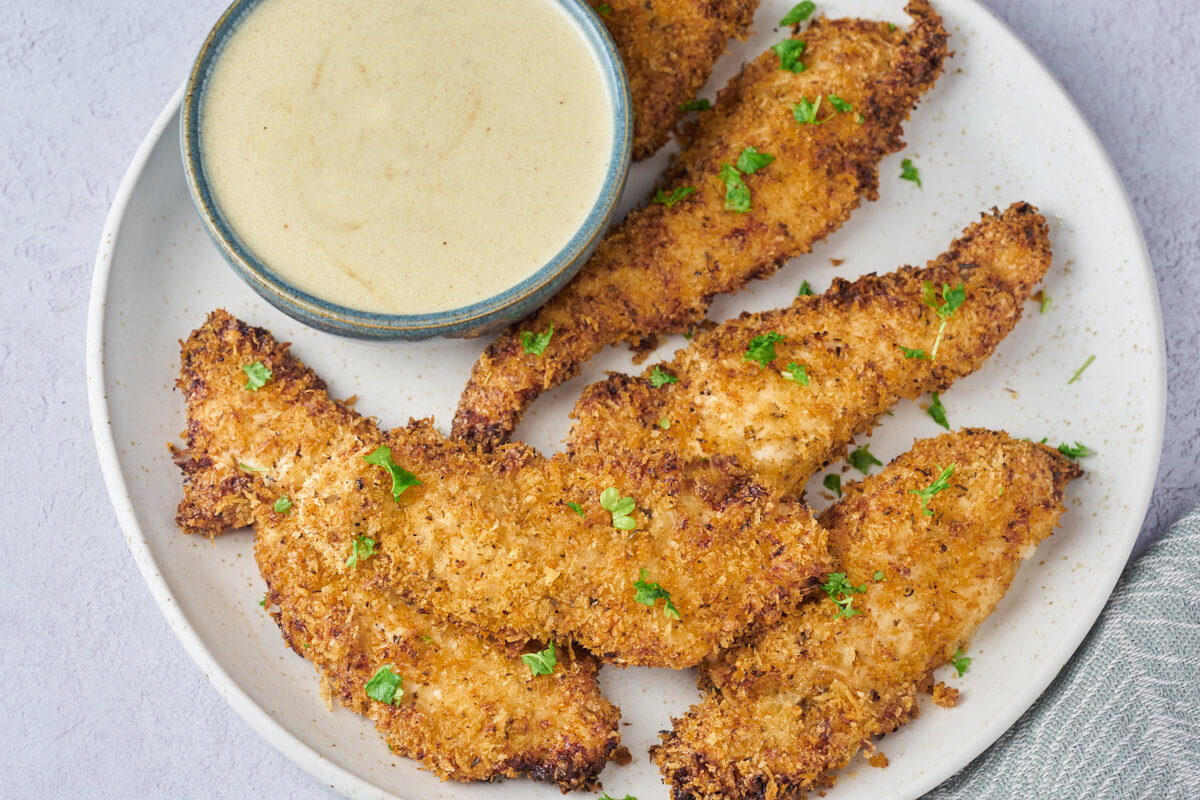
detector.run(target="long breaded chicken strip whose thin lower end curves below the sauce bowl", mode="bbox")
[454,0,947,447]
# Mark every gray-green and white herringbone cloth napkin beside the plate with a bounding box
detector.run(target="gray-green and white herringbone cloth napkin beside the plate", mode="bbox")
[924,506,1200,800]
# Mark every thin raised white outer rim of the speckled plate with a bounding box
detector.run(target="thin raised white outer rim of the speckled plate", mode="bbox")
[85,0,1168,800]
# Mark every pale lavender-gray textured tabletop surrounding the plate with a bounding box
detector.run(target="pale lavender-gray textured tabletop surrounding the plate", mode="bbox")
[0,0,1200,798]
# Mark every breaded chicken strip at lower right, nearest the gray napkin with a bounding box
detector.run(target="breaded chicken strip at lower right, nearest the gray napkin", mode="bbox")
[652,431,1080,800]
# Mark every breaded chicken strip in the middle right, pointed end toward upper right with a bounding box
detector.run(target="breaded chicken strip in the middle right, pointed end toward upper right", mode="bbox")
[568,203,1050,493]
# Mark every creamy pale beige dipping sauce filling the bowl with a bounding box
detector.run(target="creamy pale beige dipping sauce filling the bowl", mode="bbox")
[200,0,614,314]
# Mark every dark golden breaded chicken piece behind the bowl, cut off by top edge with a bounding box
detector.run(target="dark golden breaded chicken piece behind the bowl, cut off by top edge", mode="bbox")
[593,0,758,161]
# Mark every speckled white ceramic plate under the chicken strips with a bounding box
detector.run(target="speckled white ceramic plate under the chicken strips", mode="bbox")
[88,0,1166,800]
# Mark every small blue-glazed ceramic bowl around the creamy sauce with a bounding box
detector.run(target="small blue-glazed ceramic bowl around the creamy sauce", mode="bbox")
[180,0,634,339]
